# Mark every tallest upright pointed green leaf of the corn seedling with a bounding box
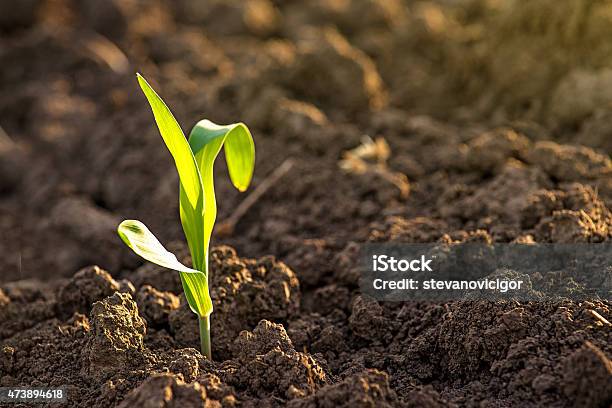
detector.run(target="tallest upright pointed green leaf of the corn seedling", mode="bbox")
[137,74,212,316]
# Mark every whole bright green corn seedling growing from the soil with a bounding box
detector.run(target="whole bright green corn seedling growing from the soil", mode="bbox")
[117,74,255,359]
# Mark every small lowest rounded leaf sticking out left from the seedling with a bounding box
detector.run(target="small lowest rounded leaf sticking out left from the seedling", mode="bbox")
[117,220,202,274]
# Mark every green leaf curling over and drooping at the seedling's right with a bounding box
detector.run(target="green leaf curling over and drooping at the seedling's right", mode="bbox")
[189,119,255,260]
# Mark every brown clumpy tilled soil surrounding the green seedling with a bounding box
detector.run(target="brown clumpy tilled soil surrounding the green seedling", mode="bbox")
[0,0,612,407]
